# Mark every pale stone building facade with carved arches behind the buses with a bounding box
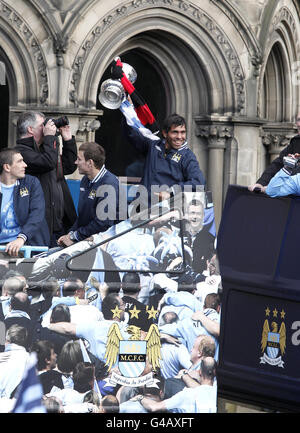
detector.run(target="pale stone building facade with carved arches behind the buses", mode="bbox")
[0,0,300,223]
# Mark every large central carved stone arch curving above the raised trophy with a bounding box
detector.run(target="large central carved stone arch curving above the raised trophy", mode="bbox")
[71,2,246,115]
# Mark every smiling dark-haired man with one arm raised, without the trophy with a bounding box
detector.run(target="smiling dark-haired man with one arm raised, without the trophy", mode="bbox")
[120,101,205,206]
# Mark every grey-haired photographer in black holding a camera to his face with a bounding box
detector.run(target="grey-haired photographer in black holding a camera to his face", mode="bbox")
[16,111,77,247]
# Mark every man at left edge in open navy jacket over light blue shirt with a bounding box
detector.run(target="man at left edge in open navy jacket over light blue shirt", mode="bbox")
[0,148,50,256]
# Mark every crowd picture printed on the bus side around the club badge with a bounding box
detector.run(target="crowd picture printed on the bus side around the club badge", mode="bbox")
[0,183,221,413]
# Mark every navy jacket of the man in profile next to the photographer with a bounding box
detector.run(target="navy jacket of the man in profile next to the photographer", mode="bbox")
[71,167,119,241]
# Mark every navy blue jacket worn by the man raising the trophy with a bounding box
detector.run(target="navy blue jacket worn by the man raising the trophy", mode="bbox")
[124,122,205,202]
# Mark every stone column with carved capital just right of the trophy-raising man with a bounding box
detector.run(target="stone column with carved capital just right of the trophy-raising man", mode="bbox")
[197,123,233,227]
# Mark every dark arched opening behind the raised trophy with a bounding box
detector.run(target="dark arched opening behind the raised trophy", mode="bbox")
[95,50,166,177]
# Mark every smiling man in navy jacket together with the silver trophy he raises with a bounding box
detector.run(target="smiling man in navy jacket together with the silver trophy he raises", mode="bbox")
[99,57,205,211]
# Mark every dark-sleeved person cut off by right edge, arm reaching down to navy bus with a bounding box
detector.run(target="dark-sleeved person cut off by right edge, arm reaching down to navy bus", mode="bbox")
[248,111,300,192]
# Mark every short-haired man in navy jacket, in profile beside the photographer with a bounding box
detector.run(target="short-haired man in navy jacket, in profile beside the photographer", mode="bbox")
[58,142,119,246]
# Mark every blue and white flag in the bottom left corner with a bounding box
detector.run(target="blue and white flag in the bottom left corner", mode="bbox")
[12,352,47,413]
